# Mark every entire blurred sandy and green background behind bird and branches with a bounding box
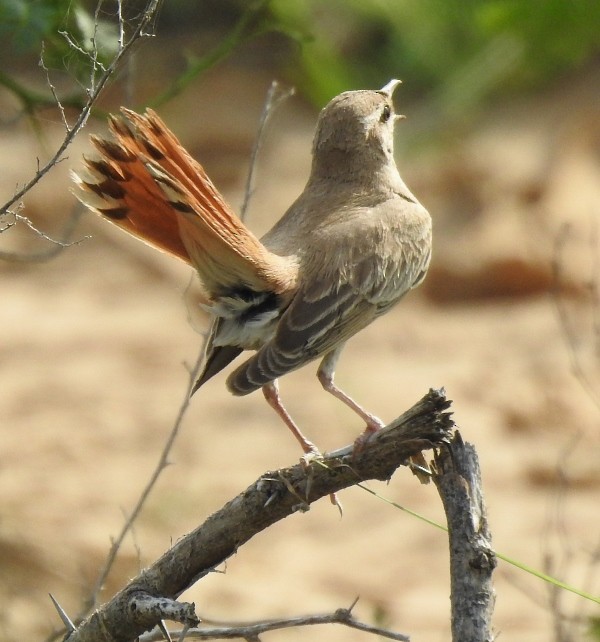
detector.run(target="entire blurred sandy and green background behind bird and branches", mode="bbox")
[0,0,600,642]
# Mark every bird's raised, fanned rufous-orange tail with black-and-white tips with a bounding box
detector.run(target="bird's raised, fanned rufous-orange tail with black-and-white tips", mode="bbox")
[74,109,295,296]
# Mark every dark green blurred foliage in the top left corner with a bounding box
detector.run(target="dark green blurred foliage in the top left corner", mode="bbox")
[0,0,294,115]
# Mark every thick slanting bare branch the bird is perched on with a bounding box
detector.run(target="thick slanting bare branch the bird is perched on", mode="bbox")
[62,390,453,642]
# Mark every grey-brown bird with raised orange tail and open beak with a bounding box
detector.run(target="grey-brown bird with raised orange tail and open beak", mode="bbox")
[73,79,432,456]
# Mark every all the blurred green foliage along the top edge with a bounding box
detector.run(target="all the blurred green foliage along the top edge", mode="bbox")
[0,0,600,122]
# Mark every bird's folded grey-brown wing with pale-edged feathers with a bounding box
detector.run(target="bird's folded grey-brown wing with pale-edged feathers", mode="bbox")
[227,200,430,395]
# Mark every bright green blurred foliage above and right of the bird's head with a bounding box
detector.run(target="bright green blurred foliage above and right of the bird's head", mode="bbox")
[271,0,600,113]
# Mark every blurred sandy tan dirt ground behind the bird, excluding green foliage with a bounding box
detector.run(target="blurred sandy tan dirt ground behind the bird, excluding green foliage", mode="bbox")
[0,46,600,642]
